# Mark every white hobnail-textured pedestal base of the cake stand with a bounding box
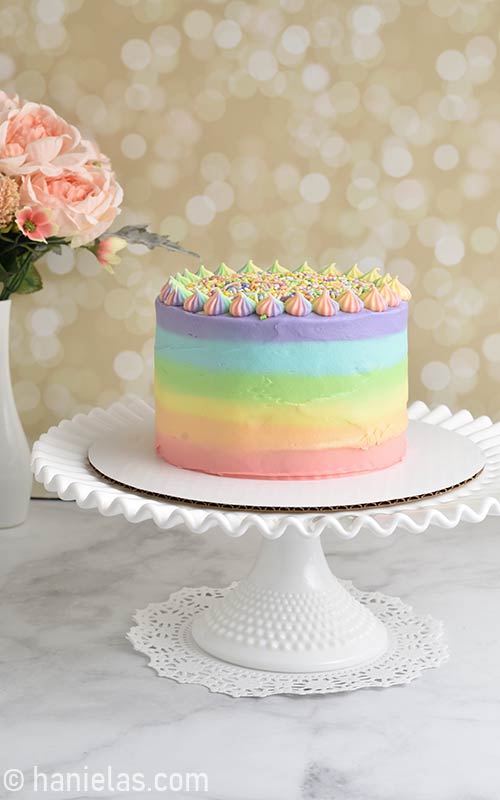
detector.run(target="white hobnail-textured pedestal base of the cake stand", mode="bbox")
[192,531,388,672]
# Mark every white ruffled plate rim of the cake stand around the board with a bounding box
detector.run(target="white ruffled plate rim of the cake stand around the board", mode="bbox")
[32,396,500,539]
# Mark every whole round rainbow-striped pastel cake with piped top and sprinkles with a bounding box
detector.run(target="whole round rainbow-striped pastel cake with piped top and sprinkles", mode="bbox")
[155,262,410,480]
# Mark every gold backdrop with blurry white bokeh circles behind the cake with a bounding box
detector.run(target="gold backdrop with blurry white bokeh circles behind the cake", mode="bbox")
[0,0,500,439]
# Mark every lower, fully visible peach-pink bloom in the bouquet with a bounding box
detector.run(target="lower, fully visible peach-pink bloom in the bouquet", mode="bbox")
[20,159,123,247]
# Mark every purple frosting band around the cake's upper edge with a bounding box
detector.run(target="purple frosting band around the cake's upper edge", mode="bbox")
[156,299,408,342]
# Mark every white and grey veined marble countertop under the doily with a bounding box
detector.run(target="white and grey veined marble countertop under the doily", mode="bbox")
[0,500,500,800]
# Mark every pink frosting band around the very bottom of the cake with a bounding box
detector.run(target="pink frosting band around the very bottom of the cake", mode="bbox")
[156,433,406,480]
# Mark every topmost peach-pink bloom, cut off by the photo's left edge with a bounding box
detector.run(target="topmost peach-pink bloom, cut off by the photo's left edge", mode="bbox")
[0,101,93,176]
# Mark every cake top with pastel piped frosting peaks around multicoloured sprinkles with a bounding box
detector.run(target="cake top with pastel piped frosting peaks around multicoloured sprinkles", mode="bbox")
[158,261,411,319]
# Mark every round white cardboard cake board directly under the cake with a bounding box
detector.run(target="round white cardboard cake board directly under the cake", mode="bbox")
[88,409,485,511]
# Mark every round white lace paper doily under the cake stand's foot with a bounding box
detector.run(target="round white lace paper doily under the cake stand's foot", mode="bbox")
[127,581,449,697]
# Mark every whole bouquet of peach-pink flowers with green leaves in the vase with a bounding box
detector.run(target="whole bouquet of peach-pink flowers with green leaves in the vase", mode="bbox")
[0,91,196,300]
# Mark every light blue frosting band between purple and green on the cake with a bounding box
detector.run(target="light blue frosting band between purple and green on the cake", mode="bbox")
[155,327,408,376]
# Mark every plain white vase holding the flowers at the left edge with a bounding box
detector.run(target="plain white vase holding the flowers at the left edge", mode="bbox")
[0,300,32,528]
